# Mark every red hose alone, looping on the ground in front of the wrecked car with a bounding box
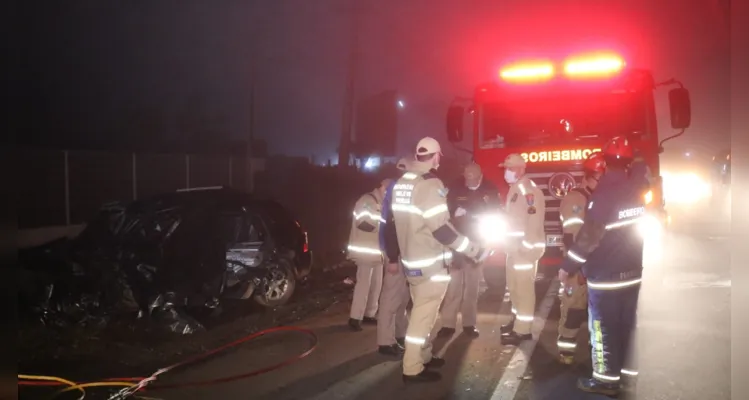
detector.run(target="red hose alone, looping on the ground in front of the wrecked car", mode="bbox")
[18,326,318,391]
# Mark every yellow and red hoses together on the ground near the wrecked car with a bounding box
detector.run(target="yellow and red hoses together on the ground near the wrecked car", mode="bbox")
[18,326,318,400]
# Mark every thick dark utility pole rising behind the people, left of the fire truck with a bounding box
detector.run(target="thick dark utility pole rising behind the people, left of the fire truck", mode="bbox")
[338,3,361,167]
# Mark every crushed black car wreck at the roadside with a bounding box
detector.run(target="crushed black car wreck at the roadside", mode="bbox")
[19,187,312,333]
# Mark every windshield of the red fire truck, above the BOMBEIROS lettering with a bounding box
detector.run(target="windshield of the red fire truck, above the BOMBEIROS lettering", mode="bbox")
[478,92,652,148]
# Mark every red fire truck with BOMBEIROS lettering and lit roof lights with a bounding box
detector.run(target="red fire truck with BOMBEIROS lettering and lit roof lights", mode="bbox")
[447,52,691,289]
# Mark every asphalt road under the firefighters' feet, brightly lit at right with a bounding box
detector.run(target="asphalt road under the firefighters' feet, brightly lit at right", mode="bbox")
[109,212,730,400]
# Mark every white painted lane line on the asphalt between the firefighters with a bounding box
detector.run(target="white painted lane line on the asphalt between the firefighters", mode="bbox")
[491,279,559,400]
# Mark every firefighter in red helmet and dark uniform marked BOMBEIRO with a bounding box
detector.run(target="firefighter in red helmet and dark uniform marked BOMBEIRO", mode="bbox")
[559,137,648,396]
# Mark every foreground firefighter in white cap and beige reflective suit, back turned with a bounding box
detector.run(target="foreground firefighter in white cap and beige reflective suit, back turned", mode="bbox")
[391,137,490,382]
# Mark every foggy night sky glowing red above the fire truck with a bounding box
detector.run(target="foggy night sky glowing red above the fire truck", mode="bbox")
[20,0,730,158]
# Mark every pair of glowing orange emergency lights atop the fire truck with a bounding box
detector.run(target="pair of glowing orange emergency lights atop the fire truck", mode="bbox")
[499,53,626,82]
